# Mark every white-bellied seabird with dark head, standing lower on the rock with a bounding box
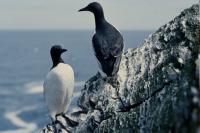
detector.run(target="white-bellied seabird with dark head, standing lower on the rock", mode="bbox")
[43,45,77,130]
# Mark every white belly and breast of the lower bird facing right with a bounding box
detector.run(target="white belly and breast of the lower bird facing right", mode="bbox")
[44,63,74,119]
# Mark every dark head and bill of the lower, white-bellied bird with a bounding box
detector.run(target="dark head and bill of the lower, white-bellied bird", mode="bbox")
[50,45,67,58]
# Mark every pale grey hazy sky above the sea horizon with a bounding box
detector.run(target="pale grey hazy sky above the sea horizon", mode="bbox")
[0,0,199,30]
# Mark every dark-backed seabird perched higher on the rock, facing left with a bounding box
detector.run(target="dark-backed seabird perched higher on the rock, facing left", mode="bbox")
[79,2,124,77]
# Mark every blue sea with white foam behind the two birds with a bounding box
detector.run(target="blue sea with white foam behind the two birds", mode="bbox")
[0,31,151,133]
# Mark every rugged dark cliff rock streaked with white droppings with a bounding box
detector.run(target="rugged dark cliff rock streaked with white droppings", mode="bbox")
[41,5,200,133]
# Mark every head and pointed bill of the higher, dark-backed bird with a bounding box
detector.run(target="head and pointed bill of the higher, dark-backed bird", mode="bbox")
[79,2,103,14]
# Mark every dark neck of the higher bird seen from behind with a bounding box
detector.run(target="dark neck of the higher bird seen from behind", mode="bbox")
[94,10,106,30]
